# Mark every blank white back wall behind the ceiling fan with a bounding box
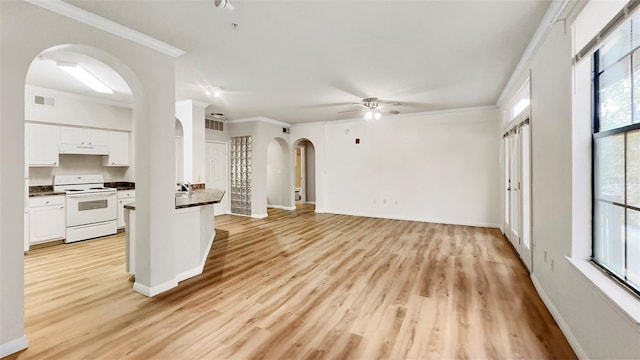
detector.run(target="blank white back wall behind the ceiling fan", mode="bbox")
[316,109,500,227]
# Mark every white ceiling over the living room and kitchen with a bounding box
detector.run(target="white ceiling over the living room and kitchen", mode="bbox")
[27,0,551,123]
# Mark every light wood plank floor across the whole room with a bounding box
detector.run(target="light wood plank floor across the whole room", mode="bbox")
[10,206,575,359]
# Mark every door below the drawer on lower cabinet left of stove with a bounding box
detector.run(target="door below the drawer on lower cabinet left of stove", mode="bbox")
[29,205,65,244]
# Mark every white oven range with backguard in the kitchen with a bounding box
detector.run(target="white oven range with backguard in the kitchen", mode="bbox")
[53,175,118,243]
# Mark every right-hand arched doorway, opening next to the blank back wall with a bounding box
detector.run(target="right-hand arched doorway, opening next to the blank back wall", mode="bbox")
[293,139,317,210]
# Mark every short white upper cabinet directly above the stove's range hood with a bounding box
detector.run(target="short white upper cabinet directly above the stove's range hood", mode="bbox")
[59,126,109,155]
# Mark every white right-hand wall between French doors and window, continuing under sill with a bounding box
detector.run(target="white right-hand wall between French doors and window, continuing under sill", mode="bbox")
[498,1,640,359]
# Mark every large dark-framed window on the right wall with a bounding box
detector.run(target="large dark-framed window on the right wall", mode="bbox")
[592,14,640,295]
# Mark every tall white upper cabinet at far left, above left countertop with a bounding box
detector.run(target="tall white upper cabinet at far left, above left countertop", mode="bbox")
[25,123,60,166]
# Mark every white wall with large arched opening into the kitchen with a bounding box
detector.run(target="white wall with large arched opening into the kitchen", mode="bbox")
[0,1,176,354]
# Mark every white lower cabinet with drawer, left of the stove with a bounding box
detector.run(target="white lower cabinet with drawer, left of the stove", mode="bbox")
[29,195,66,244]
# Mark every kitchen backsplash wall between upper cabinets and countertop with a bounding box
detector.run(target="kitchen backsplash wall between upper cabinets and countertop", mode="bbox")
[29,155,134,186]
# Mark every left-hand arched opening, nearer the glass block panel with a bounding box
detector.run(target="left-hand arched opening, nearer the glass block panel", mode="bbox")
[267,137,290,209]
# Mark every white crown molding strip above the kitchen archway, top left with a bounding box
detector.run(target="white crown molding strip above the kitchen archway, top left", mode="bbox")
[25,0,185,58]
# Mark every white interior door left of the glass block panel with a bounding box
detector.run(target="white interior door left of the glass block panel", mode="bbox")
[205,141,229,215]
